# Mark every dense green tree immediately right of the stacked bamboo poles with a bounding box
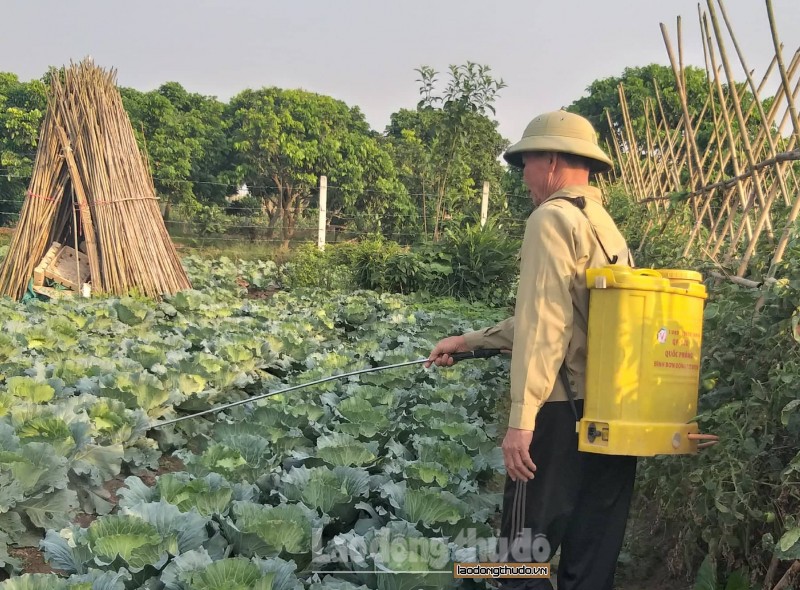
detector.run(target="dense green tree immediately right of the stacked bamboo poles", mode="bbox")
[120,82,230,218]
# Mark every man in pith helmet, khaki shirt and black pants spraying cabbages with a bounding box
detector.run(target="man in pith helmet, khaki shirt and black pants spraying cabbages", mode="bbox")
[427,111,716,590]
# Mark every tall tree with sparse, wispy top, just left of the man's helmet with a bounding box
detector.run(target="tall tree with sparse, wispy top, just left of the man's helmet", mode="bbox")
[386,62,508,239]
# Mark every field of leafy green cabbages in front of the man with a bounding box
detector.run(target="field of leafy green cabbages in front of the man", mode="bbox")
[0,258,507,590]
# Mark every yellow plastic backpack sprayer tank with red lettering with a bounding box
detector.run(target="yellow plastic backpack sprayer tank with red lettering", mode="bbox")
[578,265,707,457]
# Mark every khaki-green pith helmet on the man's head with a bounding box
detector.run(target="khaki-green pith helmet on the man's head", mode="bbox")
[503,111,613,173]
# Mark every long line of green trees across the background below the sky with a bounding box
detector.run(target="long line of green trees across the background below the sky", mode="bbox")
[0,62,752,247]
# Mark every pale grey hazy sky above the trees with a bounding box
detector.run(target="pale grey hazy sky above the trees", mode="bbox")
[0,0,800,141]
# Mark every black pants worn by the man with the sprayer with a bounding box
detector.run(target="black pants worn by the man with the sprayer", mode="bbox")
[501,400,636,590]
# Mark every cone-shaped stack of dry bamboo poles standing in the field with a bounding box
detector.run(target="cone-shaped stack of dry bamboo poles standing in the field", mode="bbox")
[0,60,191,299]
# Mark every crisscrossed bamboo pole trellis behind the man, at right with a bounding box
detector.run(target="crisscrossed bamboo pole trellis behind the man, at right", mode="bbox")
[607,0,800,278]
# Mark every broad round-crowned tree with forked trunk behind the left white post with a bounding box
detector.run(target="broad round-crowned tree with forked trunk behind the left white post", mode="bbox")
[227,88,408,245]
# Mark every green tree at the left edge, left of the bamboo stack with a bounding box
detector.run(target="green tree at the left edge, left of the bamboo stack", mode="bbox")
[0,73,47,225]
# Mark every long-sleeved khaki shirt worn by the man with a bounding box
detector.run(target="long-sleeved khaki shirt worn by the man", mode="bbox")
[464,186,632,430]
